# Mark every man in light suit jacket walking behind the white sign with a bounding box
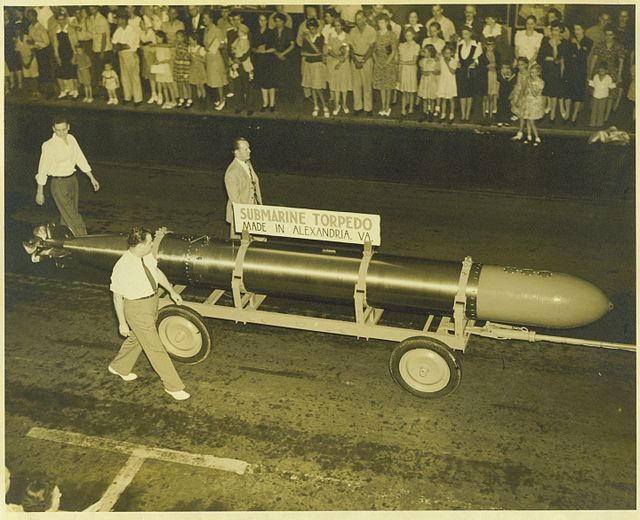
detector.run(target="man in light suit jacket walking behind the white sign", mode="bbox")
[224,137,262,239]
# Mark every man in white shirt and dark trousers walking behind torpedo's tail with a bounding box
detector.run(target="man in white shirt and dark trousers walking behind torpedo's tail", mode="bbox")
[36,118,100,236]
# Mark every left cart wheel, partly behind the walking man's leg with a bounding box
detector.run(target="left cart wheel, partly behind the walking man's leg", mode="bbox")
[156,305,211,365]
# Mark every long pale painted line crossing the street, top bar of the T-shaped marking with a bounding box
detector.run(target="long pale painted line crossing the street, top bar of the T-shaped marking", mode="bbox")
[27,427,252,475]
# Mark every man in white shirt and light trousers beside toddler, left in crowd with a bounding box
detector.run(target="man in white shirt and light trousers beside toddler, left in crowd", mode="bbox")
[111,16,142,106]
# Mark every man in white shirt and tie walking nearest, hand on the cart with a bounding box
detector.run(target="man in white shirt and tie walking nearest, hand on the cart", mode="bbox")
[108,226,190,401]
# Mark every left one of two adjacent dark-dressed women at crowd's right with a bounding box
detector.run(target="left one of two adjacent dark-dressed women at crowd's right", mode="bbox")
[538,21,567,123]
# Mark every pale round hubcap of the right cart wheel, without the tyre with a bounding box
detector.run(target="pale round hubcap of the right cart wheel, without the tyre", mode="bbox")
[399,349,451,392]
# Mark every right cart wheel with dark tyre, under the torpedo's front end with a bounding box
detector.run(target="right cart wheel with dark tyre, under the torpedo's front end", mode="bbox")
[389,336,462,399]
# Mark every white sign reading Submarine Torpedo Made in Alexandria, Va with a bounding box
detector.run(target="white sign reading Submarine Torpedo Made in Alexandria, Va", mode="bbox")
[233,203,380,246]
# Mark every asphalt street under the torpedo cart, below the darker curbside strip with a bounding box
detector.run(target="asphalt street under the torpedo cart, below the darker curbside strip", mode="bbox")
[5,150,636,511]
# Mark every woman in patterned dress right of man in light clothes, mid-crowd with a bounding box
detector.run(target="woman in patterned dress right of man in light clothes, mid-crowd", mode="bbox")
[373,14,398,117]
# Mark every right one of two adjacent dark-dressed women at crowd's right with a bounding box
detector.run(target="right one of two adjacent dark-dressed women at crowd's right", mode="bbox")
[560,23,593,126]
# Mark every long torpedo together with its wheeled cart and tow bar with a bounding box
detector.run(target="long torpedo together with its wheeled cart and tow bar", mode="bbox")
[24,224,635,397]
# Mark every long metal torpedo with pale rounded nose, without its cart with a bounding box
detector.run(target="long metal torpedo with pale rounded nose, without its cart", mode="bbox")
[24,225,613,328]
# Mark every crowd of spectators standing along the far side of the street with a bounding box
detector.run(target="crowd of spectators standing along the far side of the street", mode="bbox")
[4,5,635,132]
